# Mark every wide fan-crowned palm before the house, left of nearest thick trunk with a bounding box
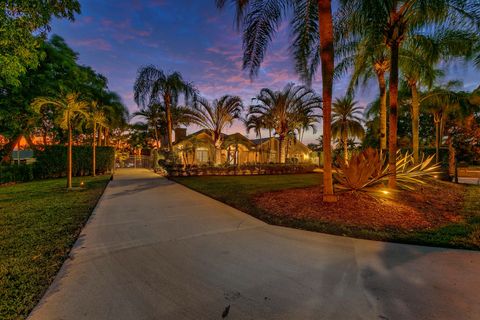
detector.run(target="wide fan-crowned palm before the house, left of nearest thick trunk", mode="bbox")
[249,83,321,163]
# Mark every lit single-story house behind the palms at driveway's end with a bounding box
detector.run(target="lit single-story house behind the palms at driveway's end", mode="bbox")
[173,128,318,165]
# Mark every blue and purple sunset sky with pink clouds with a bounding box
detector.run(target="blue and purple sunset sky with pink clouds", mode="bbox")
[52,0,480,142]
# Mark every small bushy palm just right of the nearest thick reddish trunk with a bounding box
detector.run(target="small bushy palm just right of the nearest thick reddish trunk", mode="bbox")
[332,96,365,162]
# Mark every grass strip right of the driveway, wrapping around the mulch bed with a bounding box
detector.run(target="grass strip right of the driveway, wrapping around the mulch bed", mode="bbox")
[173,174,480,250]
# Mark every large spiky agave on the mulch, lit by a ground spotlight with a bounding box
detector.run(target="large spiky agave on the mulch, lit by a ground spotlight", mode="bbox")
[334,148,440,192]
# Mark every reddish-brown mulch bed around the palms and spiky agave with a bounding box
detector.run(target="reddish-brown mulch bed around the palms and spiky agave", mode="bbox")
[255,182,463,231]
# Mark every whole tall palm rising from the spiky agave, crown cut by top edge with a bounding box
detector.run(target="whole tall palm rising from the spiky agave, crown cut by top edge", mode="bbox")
[340,0,480,188]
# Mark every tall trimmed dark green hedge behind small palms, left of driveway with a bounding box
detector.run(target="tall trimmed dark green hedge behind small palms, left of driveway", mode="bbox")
[33,145,115,179]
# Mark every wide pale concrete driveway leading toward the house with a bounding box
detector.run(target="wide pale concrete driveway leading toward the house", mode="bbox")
[30,169,480,320]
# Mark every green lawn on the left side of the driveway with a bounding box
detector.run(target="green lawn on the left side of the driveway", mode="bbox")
[0,176,110,319]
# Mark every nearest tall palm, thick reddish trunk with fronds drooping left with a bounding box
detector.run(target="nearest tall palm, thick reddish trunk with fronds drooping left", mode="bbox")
[216,0,337,202]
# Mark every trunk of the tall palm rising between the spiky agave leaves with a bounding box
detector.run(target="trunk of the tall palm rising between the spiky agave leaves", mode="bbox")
[388,41,399,189]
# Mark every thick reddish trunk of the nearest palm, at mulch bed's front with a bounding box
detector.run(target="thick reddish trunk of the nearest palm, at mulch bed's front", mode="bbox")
[318,0,337,202]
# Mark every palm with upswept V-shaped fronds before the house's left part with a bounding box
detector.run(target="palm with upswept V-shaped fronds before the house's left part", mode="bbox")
[188,95,243,165]
